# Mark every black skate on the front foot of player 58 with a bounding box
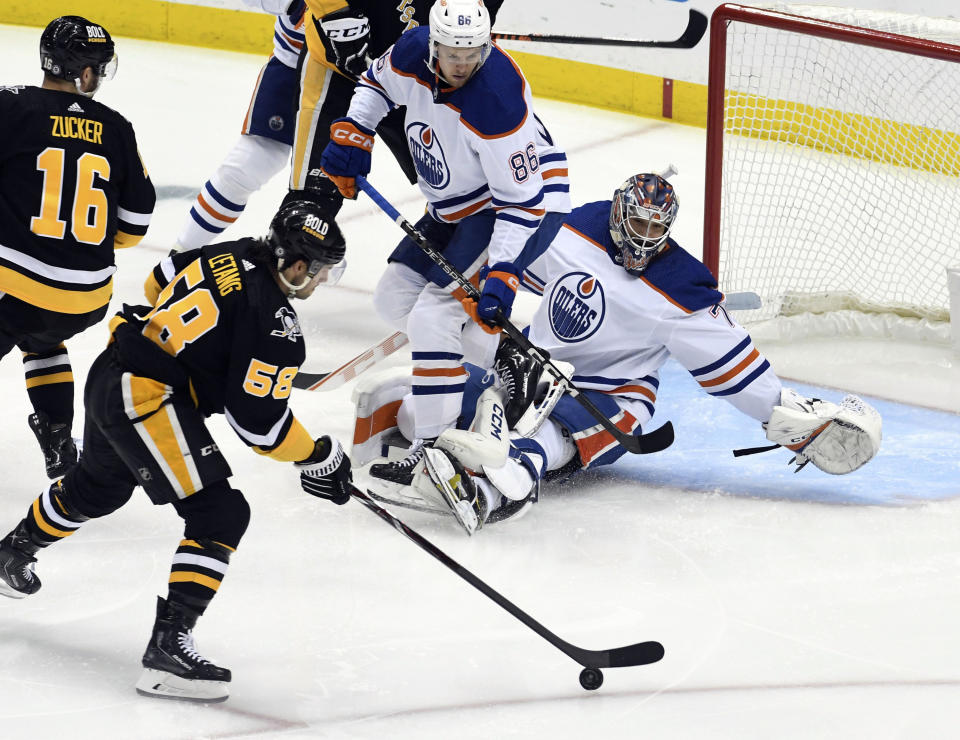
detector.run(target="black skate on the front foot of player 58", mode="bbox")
[137,596,231,702]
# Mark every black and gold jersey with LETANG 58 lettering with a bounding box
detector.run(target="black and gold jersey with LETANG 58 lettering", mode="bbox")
[120,239,314,462]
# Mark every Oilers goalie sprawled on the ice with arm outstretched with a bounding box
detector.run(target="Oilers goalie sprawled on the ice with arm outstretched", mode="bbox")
[355,174,881,533]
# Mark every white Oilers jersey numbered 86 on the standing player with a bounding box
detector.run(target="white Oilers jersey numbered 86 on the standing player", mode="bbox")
[348,27,570,264]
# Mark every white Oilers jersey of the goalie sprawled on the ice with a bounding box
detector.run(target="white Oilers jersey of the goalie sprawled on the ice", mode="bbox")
[521,201,780,422]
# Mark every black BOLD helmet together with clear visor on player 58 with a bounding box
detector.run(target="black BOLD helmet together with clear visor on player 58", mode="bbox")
[266,200,347,296]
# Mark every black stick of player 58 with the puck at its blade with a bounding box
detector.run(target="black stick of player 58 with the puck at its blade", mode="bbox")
[350,486,664,688]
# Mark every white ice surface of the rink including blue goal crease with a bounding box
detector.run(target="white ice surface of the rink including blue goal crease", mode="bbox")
[0,27,960,740]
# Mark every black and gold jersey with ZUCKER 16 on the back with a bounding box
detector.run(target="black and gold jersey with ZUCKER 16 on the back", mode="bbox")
[0,86,156,314]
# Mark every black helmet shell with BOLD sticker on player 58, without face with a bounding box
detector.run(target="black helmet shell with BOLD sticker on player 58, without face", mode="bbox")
[267,200,347,273]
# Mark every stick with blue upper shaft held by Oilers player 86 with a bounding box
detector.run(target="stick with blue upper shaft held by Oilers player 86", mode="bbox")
[356,175,673,455]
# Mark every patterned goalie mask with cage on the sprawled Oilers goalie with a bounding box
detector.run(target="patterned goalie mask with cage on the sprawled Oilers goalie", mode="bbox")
[610,173,680,276]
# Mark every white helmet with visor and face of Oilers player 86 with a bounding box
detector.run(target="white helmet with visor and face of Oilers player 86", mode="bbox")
[427,0,493,87]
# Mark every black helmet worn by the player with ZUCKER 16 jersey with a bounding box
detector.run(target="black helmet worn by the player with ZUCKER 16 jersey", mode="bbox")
[40,15,117,81]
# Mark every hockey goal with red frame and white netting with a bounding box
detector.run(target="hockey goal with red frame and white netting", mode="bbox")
[704,4,960,333]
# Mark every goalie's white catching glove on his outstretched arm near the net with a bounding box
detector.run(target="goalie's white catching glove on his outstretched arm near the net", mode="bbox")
[763,388,882,475]
